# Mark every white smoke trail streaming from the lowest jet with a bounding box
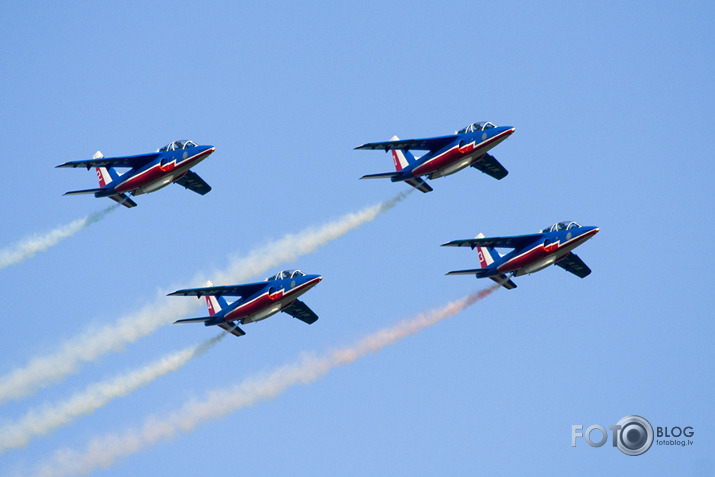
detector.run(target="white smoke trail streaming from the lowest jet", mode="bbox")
[0,332,228,454]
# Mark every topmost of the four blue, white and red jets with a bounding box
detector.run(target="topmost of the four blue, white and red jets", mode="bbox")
[355,122,515,192]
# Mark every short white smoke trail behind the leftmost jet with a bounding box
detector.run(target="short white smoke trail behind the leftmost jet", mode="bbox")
[0,204,119,270]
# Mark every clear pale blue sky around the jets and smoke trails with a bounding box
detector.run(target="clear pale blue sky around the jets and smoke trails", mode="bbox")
[0,2,715,476]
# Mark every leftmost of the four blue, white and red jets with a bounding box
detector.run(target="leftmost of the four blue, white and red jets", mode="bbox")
[57,140,216,207]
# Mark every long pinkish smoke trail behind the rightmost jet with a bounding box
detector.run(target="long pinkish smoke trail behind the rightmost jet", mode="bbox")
[32,285,500,477]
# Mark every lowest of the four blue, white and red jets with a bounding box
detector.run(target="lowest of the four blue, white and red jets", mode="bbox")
[169,270,323,336]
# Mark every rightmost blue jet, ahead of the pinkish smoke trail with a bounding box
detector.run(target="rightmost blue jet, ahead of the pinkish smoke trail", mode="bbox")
[442,221,599,290]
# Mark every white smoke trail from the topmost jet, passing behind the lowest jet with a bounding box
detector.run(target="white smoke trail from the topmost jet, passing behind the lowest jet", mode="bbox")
[0,189,411,403]
